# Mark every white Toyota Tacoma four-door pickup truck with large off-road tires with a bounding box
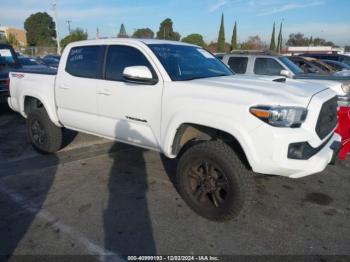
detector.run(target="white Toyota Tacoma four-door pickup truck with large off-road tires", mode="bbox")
[8,39,340,221]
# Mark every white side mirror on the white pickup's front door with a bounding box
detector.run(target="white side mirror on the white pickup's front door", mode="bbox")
[123,66,158,85]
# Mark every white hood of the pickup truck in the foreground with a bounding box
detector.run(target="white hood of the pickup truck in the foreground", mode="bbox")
[183,75,328,107]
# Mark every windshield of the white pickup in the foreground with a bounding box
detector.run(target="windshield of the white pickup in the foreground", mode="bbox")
[148,44,233,81]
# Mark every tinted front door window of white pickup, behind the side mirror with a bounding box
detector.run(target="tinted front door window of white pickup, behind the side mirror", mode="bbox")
[106,45,155,81]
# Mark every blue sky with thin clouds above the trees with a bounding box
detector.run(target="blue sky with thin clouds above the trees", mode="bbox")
[0,0,350,46]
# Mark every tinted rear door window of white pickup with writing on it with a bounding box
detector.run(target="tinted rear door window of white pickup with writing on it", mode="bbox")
[66,46,104,78]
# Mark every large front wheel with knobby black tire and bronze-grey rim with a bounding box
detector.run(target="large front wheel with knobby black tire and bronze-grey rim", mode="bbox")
[176,141,255,222]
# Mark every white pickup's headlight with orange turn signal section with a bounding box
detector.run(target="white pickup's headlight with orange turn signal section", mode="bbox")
[249,106,307,128]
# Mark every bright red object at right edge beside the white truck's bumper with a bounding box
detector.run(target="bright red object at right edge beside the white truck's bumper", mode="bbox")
[337,106,350,160]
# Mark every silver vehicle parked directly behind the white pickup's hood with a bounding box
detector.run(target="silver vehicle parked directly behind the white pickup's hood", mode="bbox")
[223,53,350,106]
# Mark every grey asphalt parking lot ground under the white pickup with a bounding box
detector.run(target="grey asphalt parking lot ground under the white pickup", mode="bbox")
[0,105,350,258]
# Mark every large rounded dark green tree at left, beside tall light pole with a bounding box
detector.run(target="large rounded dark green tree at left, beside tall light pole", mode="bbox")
[24,12,56,46]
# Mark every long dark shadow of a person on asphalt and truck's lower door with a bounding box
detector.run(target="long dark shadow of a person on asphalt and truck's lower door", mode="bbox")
[103,121,156,256]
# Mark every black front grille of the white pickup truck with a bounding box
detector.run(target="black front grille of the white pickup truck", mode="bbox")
[316,96,338,139]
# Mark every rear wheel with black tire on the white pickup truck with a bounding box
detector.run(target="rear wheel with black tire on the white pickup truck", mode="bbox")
[27,108,62,154]
